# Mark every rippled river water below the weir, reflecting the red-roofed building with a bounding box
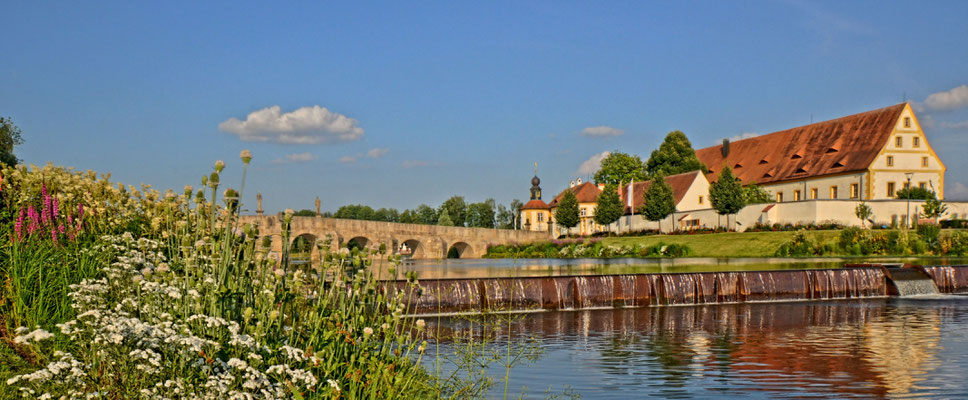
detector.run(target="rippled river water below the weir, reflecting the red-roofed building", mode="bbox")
[436,296,968,398]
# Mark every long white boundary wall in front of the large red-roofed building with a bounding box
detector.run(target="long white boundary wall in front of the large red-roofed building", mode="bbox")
[609,199,968,232]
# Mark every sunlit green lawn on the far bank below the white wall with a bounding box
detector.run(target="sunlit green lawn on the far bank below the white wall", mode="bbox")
[602,230,840,257]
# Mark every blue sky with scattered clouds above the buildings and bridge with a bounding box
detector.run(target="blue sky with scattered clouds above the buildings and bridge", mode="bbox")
[0,1,968,212]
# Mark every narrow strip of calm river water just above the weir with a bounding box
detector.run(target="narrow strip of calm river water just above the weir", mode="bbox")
[374,257,968,279]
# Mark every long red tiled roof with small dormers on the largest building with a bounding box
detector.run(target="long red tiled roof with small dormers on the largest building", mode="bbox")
[696,103,907,184]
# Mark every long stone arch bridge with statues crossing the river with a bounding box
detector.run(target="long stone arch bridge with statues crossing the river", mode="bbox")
[240,215,551,259]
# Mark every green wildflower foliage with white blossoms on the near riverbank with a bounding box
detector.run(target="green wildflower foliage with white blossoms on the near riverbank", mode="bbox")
[0,157,536,399]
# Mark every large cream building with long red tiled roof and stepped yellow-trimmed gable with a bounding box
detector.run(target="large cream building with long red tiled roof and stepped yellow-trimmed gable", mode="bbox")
[696,103,945,208]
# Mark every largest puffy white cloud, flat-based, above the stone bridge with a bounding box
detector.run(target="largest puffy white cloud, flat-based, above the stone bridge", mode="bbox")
[218,106,363,144]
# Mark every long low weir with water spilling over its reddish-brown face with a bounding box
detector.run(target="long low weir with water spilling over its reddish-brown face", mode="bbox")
[385,264,968,314]
